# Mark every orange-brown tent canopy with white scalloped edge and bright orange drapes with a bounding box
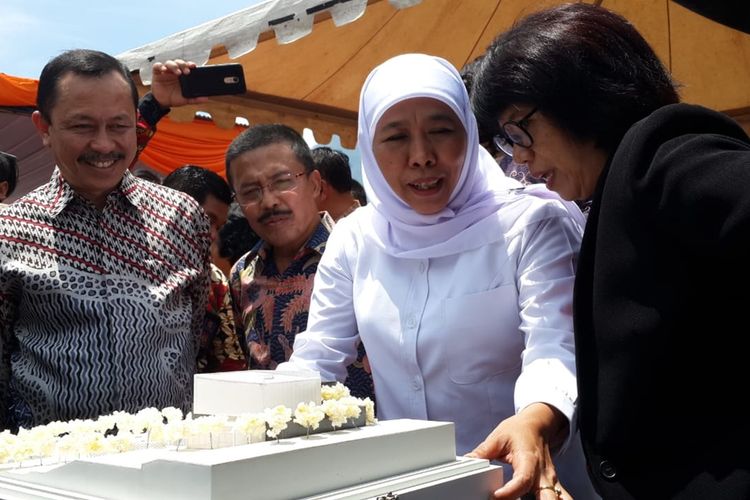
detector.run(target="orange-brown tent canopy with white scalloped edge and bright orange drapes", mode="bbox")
[0,0,750,201]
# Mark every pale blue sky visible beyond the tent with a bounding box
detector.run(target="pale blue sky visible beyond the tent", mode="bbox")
[0,0,361,179]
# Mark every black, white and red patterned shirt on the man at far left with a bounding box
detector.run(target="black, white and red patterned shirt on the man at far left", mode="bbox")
[0,169,210,428]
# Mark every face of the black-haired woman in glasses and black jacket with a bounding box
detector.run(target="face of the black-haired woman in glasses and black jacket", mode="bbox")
[498,105,607,200]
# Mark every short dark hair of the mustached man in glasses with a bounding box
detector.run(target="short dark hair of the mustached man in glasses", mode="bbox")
[226,123,315,185]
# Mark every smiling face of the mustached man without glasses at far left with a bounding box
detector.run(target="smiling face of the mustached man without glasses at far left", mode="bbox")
[32,72,136,208]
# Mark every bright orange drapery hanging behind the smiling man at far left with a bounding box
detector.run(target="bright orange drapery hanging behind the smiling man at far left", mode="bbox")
[0,73,244,176]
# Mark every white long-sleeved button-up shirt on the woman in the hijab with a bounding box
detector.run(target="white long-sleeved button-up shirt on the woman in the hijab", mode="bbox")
[282,189,582,454]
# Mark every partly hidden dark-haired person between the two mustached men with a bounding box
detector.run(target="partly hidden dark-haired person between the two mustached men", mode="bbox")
[162,165,247,372]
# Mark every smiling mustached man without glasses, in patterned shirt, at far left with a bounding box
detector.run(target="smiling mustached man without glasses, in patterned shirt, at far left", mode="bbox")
[0,50,210,429]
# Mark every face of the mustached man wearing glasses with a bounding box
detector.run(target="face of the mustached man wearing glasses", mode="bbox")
[230,143,320,256]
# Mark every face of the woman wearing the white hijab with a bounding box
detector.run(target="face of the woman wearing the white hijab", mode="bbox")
[372,97,466,215]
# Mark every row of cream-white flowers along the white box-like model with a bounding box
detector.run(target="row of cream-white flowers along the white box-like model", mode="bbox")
[0,383,376,467]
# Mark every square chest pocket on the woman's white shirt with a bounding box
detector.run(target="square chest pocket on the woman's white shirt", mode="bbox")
[442,283,524,384]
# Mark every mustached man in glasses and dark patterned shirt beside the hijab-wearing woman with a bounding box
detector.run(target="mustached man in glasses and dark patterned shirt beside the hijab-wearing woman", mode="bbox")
[226,124,372,397]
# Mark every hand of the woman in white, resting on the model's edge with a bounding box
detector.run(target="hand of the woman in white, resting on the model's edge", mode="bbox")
[466,403,572,500]
